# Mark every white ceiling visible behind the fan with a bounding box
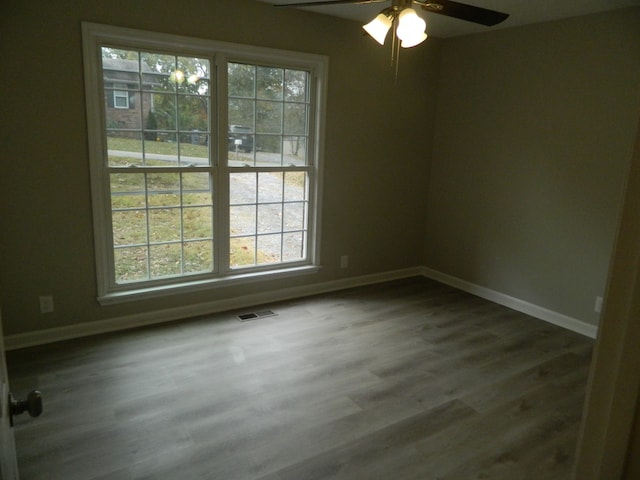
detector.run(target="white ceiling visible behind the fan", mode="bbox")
[259,0,640,38]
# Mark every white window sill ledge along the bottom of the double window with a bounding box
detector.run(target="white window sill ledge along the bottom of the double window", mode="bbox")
[98,265,321,306]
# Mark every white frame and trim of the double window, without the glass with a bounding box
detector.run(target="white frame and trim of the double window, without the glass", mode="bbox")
[82,22,328,305]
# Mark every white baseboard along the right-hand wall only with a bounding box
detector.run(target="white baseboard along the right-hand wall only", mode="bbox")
[422,267,598,338]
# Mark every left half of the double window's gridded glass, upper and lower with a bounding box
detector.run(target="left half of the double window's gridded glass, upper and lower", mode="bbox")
[101,46,214,285]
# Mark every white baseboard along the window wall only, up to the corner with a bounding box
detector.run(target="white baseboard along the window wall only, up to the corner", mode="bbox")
[4,267,422,350]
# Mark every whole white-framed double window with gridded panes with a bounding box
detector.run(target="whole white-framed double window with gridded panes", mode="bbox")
[83,24,326,303]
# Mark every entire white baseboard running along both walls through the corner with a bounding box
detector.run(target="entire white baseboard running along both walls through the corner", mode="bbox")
[4,267,598,350]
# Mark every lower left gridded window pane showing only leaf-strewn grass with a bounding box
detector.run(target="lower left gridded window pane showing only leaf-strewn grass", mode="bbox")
[110,170,214,284]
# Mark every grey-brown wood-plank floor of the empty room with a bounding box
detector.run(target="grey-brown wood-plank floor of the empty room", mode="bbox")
[8,278,593,480]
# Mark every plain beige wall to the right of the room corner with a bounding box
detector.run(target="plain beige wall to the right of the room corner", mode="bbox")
[425,8,640,324]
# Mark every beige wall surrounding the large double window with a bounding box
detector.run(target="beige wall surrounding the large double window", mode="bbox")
[0,0,437,335]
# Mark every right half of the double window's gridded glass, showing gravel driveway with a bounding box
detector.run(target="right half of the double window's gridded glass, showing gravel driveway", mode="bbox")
[227,63,312,269]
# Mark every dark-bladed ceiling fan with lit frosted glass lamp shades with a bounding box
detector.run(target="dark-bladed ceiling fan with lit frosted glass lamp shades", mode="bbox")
[274,0,509,48]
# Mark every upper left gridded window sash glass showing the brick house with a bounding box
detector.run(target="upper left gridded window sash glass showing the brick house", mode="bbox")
[101,46,211,167]
